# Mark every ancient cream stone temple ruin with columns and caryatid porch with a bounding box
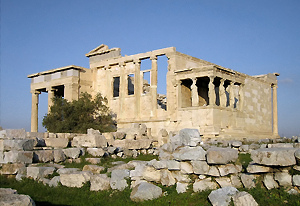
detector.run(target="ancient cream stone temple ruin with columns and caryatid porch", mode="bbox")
[28,44,279,138]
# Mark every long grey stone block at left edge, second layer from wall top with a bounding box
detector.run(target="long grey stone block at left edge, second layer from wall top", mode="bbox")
[2,139,35,151]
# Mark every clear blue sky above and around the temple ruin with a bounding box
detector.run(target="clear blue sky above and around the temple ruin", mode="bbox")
[0,0,300,136]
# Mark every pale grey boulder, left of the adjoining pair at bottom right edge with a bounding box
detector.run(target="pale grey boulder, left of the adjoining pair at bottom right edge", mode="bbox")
[208,186,239,206]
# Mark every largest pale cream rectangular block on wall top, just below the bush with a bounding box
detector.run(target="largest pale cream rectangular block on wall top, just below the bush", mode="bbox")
[72,134,107,147]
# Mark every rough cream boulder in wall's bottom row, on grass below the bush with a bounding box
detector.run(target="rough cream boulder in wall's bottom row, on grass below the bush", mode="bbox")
[60,172,91,188]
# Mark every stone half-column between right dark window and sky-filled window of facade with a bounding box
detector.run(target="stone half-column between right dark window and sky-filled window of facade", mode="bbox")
[134,59,143,118]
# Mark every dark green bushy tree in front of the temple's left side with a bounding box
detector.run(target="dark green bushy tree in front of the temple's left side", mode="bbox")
[43,93,115,133]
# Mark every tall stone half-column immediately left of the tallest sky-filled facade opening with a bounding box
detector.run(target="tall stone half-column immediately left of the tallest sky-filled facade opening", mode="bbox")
[150,56,157,117]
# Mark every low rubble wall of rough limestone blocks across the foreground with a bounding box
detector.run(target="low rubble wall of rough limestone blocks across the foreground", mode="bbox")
[0,129,300,204]
